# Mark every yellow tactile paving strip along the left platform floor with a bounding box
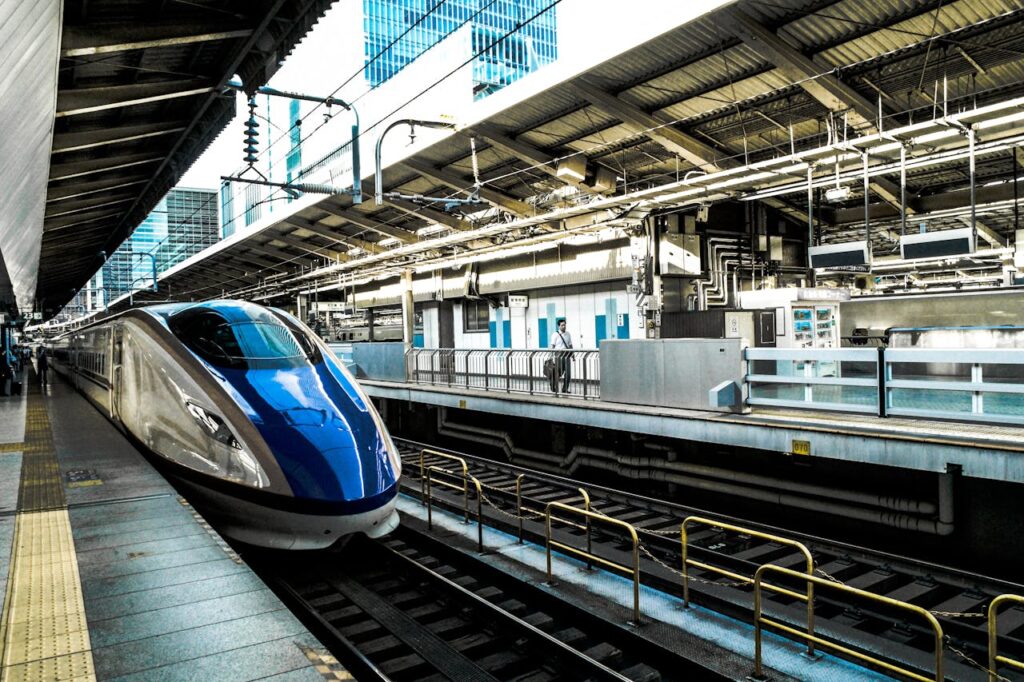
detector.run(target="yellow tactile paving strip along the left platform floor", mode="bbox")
[0,376,96,682]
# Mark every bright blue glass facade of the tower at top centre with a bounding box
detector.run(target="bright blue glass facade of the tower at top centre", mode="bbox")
[362,0,558,98]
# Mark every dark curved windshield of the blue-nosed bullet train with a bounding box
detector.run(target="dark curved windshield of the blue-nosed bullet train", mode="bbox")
[169,309,319,370]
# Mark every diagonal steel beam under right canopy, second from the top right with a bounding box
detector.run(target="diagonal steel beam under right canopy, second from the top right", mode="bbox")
[571,78,734,172]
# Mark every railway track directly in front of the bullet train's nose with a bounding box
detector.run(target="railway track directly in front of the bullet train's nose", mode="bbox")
[257,526,727,682]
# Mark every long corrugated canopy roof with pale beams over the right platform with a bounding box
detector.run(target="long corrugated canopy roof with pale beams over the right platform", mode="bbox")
[66,0,1024,313]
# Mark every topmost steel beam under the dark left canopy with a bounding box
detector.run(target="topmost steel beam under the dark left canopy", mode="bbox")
[60,22,253,57]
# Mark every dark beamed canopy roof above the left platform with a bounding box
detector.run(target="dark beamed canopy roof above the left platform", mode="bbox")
[0,0,331,312]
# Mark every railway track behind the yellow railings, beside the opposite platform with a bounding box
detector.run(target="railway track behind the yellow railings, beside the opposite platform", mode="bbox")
[396,439,1024,680]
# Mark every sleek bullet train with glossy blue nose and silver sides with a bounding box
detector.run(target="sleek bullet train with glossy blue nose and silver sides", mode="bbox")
[50,301,401,550]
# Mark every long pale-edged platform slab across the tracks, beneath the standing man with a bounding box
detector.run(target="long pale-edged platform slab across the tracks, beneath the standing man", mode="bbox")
[361,380,1024,481]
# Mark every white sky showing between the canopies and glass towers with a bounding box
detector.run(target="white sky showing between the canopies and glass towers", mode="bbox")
[178,0,731,189]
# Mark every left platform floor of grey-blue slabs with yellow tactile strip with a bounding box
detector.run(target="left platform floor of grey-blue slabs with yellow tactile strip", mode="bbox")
[0,370,351,682]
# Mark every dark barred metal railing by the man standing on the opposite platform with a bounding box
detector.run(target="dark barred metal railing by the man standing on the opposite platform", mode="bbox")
[406,348,601,398]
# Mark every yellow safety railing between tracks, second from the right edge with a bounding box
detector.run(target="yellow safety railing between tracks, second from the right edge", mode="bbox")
[754,563,945,682]
